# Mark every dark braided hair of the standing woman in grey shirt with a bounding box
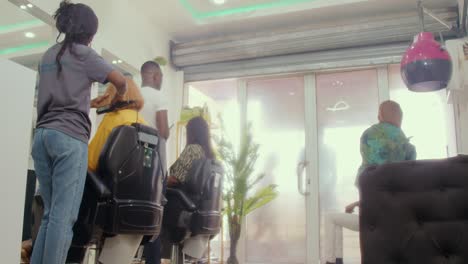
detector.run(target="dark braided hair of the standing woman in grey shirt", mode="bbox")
[54,0,99,75]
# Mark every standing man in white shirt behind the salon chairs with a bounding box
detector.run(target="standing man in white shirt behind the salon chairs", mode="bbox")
[140,61,169,264]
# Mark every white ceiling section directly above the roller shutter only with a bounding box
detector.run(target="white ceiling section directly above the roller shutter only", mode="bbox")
[138,0,457,42]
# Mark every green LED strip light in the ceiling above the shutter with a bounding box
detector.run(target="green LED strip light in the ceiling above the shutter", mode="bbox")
[179,0,317,19]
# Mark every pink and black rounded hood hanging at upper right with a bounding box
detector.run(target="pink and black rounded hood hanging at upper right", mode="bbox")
[401,32,452,92]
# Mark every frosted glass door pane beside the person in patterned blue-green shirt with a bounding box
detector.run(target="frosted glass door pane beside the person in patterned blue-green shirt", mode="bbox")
[316,70,379,264]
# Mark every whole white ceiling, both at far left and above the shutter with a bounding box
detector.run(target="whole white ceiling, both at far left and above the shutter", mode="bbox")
[0,0,457,68]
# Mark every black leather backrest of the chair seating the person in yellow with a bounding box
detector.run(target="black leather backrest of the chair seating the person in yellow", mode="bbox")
[88,124,164,235]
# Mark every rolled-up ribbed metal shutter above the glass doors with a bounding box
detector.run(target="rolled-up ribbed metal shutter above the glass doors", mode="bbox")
[171,9,458,81]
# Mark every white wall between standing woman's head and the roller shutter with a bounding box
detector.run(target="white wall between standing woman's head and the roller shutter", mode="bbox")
[31,0,183,163]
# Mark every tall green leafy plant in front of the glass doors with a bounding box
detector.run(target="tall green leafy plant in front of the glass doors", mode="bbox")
[216,122,278,264]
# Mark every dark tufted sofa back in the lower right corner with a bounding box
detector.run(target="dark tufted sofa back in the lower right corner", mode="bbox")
[359,156,468,264]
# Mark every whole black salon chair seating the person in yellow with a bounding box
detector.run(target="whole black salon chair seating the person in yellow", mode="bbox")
[35,124,164,263]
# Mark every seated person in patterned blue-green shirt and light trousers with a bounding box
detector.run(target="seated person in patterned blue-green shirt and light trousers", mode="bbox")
[324,101,416,264]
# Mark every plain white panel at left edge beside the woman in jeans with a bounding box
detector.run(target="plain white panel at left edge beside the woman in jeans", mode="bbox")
[0,60,36,263]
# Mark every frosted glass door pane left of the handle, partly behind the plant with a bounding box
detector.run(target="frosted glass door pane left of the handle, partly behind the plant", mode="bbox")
[245,77,307,264]
